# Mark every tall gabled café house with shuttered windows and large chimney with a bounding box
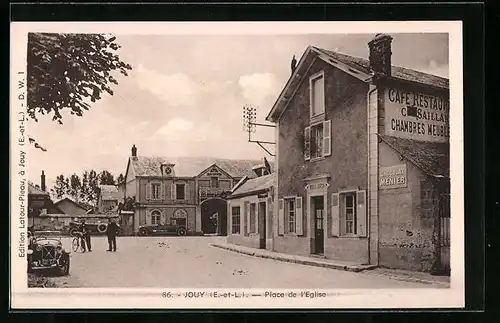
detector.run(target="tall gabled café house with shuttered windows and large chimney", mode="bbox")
[267,34,450,272]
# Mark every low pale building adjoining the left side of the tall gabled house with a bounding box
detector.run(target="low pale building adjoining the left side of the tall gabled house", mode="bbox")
[227,169,276,250]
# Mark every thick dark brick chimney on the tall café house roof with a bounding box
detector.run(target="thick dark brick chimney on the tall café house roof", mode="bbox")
[368,34,392,76]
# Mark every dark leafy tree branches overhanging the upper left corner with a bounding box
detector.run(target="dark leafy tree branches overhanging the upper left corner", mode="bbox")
[27,33,132,124]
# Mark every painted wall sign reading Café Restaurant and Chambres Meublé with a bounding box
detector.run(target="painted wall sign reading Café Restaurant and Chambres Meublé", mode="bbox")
[385,88,450,142]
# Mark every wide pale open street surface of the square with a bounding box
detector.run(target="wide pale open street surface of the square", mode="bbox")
[44,237,442,289]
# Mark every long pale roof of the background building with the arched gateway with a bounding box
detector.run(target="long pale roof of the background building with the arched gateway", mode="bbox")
[129,156,272,178]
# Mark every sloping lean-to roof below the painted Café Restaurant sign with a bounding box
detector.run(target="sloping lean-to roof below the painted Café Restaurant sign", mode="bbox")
[380,136,450,178]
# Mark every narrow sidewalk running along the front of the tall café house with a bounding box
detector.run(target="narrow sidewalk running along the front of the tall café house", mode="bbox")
[212,243,450,288]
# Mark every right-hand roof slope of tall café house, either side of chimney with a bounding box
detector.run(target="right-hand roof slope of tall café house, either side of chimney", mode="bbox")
[313,47,450,89]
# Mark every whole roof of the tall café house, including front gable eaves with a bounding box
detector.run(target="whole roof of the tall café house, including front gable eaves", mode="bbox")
[266,46,449,122]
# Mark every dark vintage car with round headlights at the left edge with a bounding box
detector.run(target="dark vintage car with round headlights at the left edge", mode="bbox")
[27,231,70,276]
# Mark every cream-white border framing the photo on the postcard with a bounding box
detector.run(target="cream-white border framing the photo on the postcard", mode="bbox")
[10,21,465,309]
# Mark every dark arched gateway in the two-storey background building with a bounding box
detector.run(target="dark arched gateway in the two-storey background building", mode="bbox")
[201,198,227,236]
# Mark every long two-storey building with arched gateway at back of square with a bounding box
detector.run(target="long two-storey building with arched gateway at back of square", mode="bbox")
[124,145,266,235]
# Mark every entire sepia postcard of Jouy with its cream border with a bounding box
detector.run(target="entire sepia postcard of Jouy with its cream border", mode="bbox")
[10,22,464,308]
